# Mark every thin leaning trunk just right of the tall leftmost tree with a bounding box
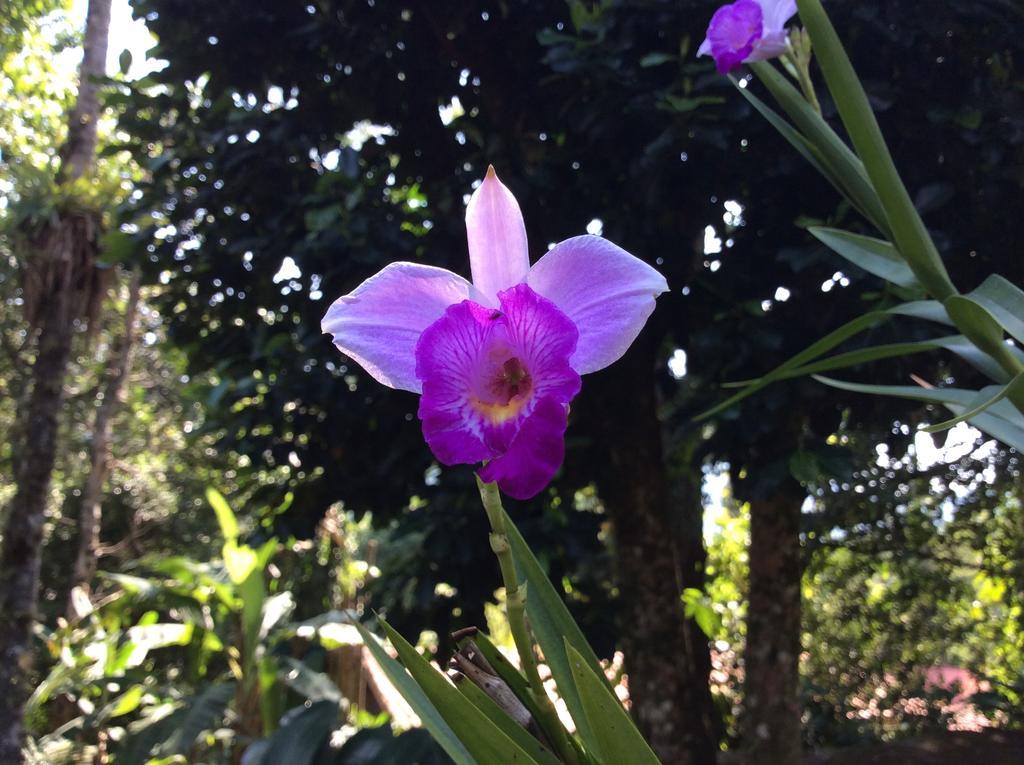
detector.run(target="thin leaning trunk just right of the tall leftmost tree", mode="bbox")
[68,270,139,621]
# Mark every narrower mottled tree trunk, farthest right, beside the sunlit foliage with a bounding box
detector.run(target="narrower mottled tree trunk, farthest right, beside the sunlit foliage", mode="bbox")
[742,479,804,765]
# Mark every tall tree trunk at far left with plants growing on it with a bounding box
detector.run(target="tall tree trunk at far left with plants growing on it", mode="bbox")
[0,0,111,765]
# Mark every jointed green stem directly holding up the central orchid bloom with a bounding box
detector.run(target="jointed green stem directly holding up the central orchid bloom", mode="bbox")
[476,476,579,765]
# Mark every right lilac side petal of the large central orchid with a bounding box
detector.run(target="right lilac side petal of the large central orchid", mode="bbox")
[526,237,669,375]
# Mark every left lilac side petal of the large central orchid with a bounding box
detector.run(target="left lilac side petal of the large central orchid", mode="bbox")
[321,263,477,393]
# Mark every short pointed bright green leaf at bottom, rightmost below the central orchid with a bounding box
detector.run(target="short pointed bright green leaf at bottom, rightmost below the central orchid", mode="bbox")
[565,641,659,765]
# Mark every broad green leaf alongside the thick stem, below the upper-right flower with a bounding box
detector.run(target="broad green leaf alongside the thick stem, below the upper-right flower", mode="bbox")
[751,61,890,238]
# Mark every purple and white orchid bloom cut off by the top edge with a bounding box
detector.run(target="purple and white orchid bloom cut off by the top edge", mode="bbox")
[697,0,797,75]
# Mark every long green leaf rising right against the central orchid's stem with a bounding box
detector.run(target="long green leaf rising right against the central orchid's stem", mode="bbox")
[502,509,611,749]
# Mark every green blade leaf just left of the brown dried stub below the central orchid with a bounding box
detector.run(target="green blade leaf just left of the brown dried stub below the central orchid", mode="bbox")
[379,619,546,765]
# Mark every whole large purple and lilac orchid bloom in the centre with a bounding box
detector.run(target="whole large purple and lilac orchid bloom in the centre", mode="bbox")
[322,168,668,499]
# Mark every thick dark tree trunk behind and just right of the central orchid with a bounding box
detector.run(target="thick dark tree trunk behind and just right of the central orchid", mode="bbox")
[584,333,718,765]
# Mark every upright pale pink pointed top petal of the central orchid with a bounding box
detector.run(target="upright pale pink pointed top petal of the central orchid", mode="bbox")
[466,167,529,305]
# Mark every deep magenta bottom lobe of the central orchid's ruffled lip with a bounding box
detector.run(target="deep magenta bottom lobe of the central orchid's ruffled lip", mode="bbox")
[480,398,567,500]
